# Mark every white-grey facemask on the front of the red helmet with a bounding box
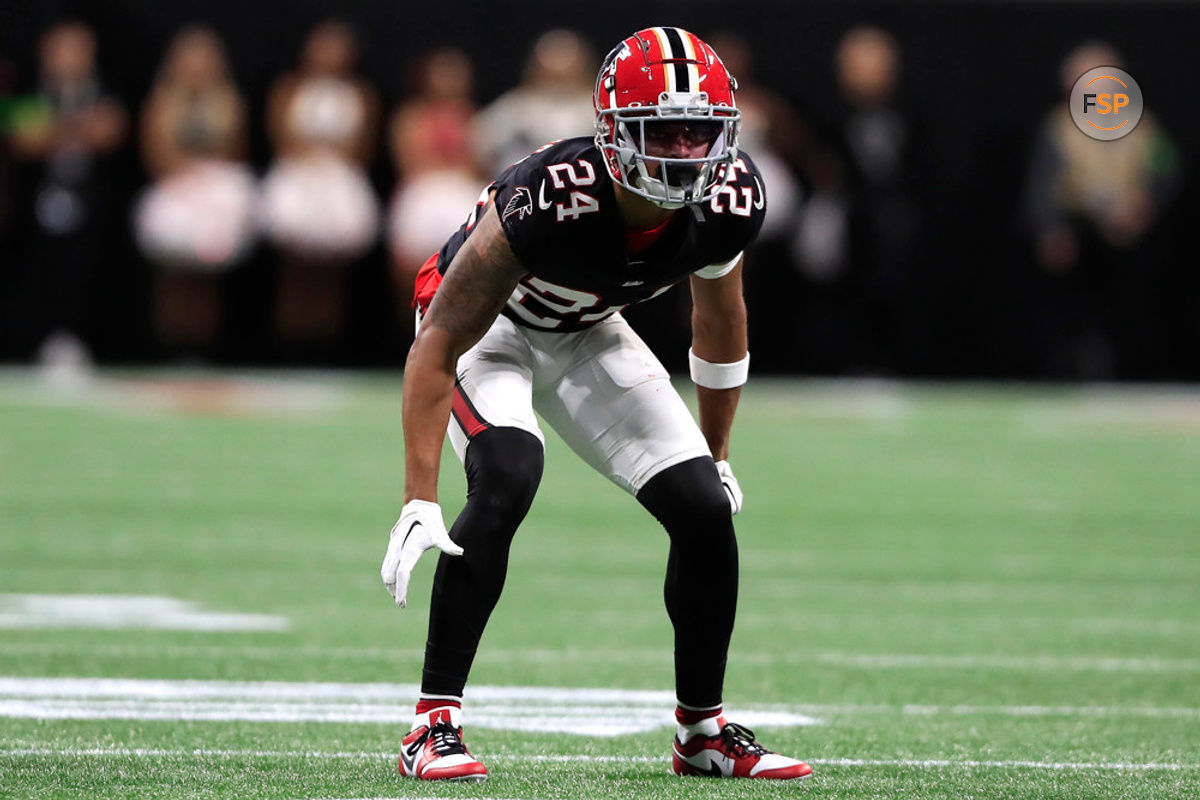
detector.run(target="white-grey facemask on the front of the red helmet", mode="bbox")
[595,92,742,209]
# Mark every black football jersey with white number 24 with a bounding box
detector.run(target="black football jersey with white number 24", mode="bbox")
[438,137,766,331]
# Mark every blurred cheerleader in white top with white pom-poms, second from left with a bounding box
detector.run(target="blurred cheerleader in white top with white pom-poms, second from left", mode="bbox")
[263,22,379,348]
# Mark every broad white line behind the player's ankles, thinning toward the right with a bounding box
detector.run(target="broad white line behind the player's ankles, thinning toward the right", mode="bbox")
[0,676,1200,735]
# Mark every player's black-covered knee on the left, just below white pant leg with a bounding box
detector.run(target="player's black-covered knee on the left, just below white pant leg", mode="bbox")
[466,428,545,519]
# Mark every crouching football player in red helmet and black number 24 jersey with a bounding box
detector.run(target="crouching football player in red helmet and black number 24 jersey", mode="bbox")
[382,28,811,780]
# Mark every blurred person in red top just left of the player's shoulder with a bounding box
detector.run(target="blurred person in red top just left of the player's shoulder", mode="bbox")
[389,49,477,331]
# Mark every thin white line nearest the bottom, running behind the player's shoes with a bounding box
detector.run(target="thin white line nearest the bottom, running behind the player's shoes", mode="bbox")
[0,747,1200,772]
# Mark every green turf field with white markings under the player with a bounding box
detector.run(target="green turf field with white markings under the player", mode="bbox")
[0,372,1200,800]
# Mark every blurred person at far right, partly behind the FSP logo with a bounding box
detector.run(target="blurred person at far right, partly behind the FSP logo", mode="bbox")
[1025,43,1180,379]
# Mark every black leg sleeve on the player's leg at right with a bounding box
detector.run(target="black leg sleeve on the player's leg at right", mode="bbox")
[637,457,738,708]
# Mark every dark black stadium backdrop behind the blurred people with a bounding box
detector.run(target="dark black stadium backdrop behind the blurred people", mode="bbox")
[0,0,1200,380]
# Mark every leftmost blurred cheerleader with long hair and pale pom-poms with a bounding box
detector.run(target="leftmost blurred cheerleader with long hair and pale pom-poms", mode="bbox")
[134,28,256,348]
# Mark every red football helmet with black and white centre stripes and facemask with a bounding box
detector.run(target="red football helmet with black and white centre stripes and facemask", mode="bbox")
[592,28,742,209]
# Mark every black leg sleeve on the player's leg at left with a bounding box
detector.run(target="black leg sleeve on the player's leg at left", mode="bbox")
[421,428,544,696]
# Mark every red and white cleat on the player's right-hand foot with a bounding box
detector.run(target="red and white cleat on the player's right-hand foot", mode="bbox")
[671,717,812,781]
